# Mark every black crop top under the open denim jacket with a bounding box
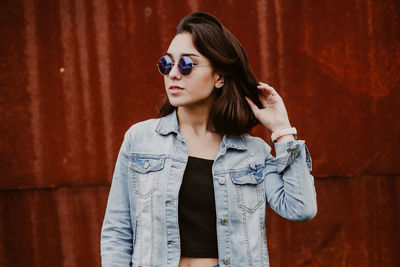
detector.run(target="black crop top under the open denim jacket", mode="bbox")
[178,157,218,258]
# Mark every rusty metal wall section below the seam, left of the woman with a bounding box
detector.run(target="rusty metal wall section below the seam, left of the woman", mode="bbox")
[0,186,109,267]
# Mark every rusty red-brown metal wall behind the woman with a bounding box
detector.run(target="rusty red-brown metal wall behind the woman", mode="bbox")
[0,0,400,267]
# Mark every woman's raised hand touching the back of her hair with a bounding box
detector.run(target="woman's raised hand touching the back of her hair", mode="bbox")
[246,82,291,132]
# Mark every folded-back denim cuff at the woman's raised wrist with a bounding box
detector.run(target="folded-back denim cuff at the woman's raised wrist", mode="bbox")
[274,140,312,173]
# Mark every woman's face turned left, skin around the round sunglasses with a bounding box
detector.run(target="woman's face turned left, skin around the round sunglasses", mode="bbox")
[164,32,219,108]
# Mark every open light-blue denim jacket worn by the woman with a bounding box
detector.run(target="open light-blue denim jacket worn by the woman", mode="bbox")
[101,112,317,267]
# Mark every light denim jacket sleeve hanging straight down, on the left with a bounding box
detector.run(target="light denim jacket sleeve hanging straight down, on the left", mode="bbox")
[100,131,134,267]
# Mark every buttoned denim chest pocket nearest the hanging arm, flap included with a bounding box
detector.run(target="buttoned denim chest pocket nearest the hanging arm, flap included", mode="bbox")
[129,154,165,198]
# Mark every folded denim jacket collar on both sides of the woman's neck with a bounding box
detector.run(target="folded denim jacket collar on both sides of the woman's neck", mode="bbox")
[156,110,247,150]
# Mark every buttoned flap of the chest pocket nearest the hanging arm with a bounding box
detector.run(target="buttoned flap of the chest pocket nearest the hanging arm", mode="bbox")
[129,154,165,173]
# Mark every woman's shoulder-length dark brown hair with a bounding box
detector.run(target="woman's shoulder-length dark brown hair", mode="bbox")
[159,12,261,136]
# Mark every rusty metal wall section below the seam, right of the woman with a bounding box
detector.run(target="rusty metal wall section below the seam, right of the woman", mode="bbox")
[267,176,400,266]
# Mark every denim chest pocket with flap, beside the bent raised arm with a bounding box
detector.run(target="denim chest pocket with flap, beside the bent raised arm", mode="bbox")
[230,167,265,213]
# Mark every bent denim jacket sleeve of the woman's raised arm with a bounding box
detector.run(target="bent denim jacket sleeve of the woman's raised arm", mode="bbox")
[264,140,317,221]
